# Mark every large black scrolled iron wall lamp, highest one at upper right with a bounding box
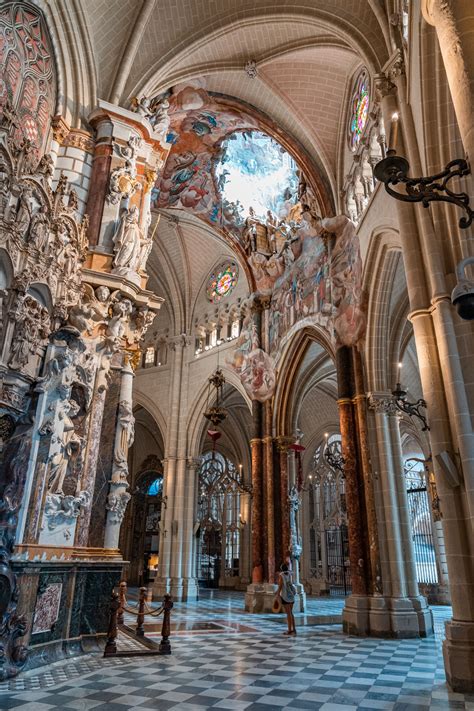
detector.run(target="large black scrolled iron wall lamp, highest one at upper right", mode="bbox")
[374,113,474,229]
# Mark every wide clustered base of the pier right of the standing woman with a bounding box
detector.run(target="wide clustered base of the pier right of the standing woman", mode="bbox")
[342,595,433,639]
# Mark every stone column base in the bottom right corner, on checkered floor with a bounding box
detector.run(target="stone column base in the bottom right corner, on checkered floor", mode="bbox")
[443,620,474,694]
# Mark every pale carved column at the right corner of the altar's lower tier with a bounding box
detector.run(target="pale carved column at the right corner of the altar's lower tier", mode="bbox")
[104,356,135,549]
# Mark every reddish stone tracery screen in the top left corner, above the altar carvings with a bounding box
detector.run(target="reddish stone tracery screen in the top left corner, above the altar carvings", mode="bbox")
[0,2,56,155]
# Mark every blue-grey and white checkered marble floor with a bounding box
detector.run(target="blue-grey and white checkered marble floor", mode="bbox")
[0,593,474,711]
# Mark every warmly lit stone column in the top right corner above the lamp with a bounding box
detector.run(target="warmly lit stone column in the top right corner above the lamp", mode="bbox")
[422,0,474,165]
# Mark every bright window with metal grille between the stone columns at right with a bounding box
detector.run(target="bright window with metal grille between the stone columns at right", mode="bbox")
[405,459,438,583]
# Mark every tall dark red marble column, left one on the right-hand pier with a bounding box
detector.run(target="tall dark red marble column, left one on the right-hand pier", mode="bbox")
[336,346,369,595]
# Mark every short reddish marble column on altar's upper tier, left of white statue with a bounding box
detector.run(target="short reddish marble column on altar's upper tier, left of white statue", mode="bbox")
[86,126,113,247]
